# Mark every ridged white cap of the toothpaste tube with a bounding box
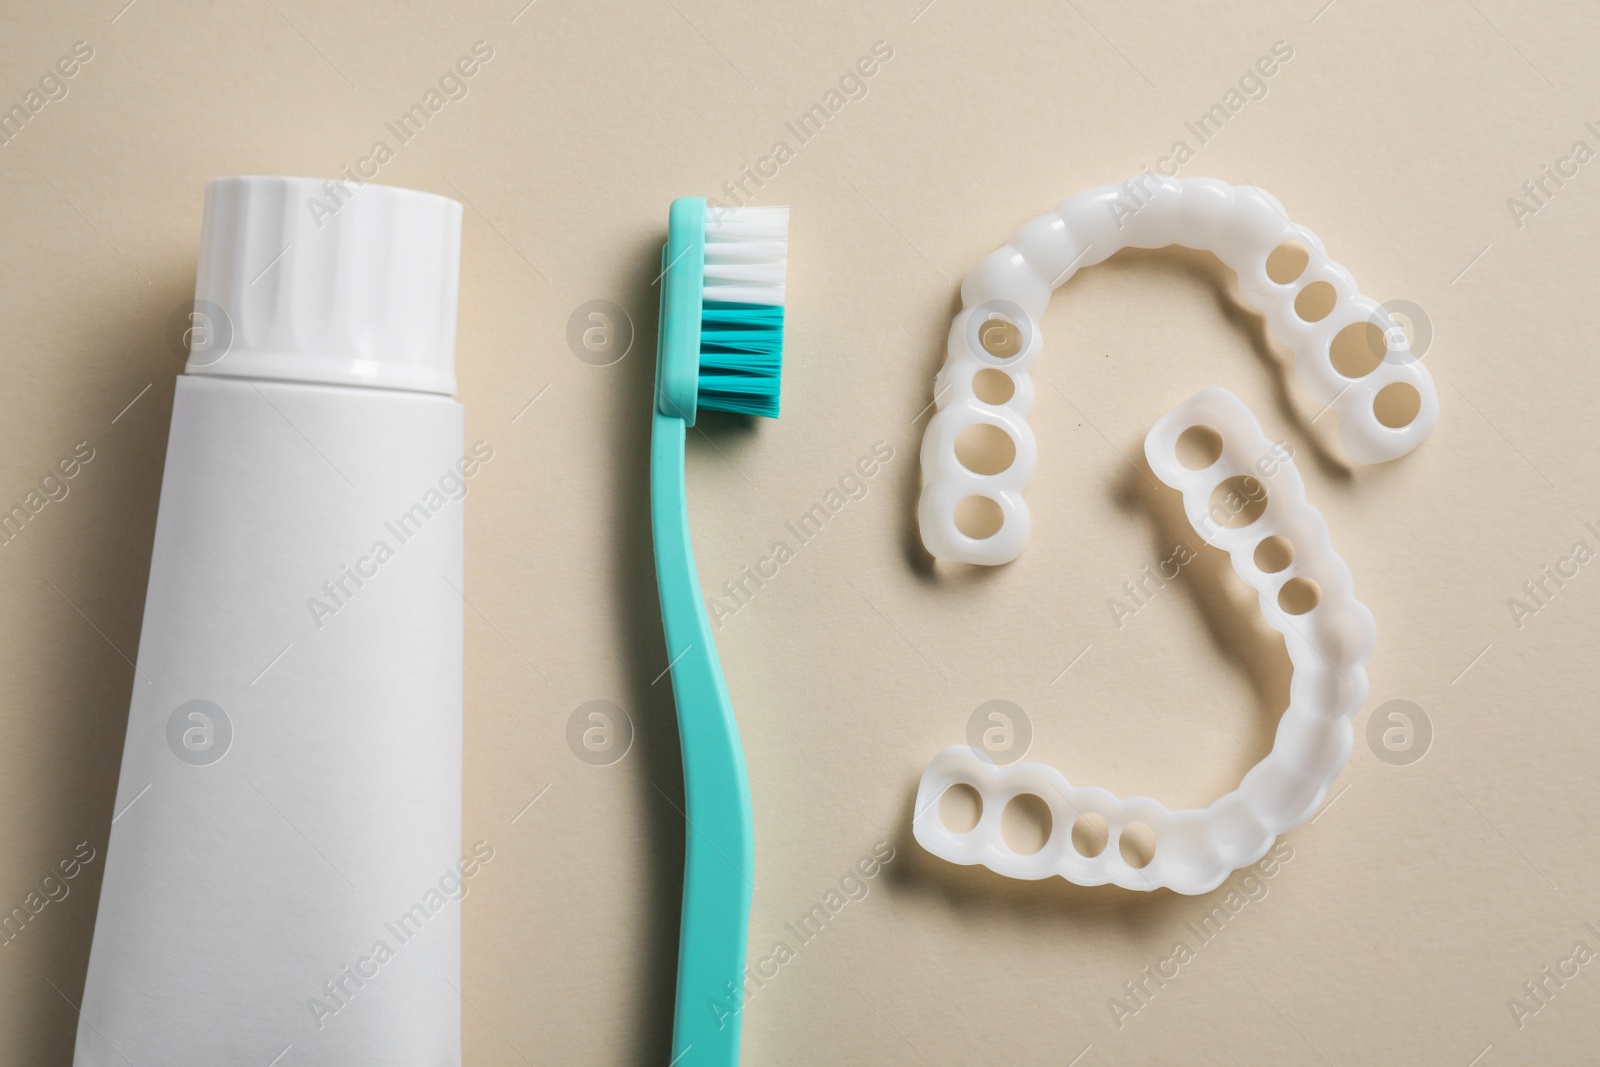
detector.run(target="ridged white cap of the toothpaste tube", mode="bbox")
[186,176,461,397]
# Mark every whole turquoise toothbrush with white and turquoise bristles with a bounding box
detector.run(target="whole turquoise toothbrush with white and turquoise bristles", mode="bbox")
[650,197,789,1067]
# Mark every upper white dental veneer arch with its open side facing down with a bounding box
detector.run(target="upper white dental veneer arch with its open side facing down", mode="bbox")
[918,174,1438,566]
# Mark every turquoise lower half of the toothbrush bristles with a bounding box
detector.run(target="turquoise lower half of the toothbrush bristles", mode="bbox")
[699,301,784,419]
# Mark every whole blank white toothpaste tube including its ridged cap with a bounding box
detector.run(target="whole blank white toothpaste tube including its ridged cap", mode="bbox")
[75,178,467,1067]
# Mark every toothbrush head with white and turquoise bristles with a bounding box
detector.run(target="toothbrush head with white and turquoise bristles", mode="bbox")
[656,197,789,426]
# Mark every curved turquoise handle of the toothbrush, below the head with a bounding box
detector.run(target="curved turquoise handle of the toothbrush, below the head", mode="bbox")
[650,404,755,1067]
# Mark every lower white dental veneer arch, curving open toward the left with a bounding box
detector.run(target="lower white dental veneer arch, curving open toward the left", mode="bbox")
[912,389,1376,894]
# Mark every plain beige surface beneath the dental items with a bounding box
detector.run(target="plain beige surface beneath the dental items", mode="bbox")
[0,0,1600,1067]
